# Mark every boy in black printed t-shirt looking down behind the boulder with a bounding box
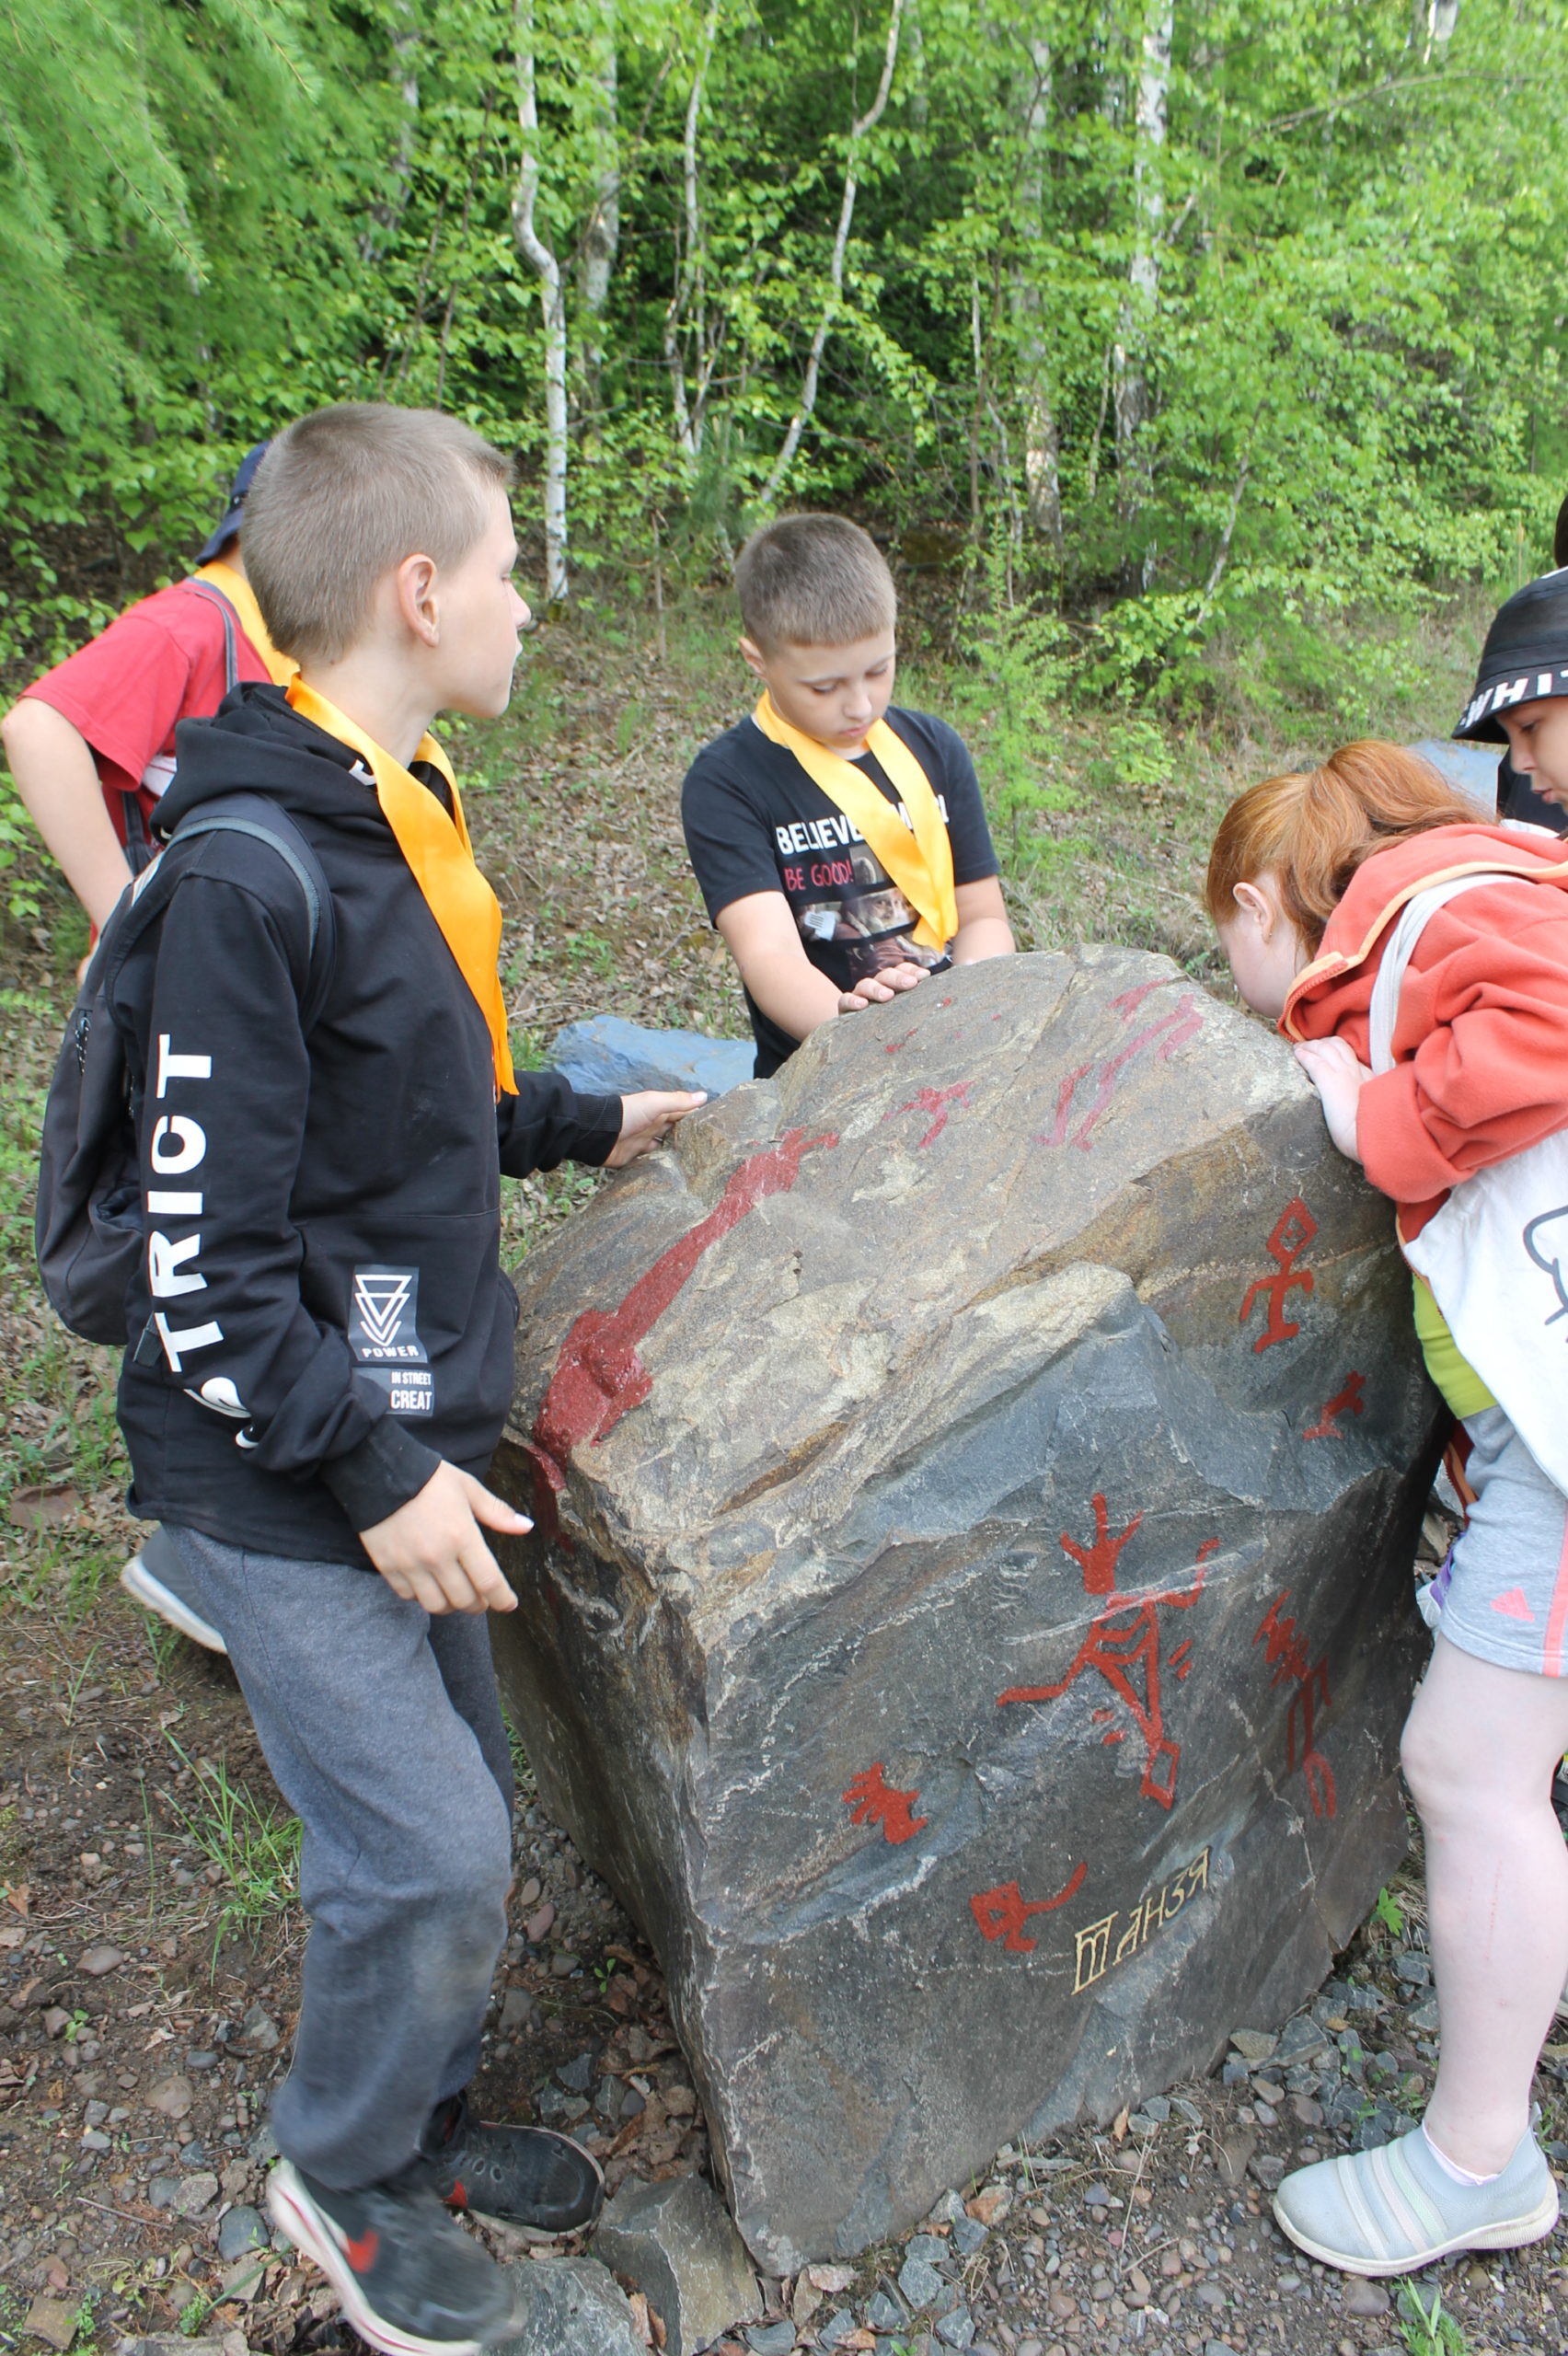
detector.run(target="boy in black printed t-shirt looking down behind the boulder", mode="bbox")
[680,516,1012,1079]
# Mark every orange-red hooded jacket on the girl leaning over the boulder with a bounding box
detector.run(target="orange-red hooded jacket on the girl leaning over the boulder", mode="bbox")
[1278,825,1568,1242]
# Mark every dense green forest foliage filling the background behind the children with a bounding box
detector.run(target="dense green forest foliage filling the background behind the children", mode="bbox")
[0,0,1568,721]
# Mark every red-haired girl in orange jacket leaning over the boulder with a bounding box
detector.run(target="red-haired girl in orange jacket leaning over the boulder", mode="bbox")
[1208,742,1568,2273]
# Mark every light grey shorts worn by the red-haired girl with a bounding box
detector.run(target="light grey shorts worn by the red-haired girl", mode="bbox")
[1422,1406,1568,1678]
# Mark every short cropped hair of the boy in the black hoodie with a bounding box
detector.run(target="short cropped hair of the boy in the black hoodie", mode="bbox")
[240,400,513,662]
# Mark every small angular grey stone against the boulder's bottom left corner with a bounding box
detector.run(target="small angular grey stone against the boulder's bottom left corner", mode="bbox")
[594,2177,763,2356]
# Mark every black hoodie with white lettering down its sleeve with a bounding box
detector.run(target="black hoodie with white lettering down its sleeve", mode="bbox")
[115,686,621,1565]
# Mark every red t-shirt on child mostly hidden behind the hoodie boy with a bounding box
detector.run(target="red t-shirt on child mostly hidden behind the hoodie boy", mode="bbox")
[24,582,271,841]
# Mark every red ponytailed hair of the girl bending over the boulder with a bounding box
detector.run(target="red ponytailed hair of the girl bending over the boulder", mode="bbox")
[1203,737,1485,950]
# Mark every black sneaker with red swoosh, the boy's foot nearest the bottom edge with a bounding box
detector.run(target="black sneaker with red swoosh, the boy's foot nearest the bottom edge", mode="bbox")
[266,2161,518,2356]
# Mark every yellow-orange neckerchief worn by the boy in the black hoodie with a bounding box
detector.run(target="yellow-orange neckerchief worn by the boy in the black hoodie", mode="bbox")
[290,678,518,1095]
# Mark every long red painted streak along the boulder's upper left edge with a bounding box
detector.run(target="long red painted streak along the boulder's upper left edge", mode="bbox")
[527,1128,838,1536]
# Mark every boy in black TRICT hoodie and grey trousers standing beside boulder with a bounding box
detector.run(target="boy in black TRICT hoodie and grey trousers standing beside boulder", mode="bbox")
[115,405,701,2356]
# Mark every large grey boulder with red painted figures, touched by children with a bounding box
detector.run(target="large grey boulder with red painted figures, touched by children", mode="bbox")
[494,950,1438,2276]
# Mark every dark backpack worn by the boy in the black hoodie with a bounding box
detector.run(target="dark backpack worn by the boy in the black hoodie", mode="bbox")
[33,794,337,1343]
